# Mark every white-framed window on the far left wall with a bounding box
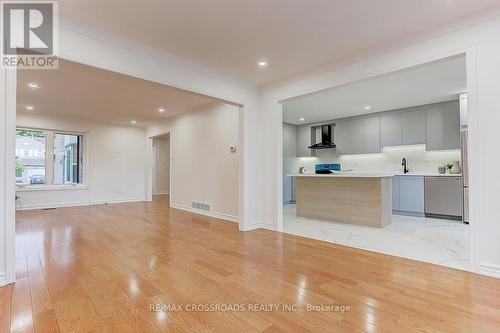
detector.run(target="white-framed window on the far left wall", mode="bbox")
[16,128,84,185]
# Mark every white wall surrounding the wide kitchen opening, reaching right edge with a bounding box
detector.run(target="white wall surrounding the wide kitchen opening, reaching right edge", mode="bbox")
[261,14,500,277]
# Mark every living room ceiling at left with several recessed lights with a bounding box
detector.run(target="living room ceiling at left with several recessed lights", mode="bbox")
[17,60,219,126]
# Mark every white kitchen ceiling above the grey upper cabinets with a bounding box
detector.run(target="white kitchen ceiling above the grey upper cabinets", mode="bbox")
[283,56,467,125]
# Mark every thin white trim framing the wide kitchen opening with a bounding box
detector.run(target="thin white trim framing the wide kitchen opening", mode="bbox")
[272,48,481,273]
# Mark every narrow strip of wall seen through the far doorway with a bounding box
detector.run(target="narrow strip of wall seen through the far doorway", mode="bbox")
[153,138,170,195]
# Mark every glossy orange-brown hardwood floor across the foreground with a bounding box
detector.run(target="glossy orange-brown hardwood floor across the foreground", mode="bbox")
[0,197,500,332]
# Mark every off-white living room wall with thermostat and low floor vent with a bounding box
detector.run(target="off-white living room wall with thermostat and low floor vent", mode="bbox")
[147,105,240,221]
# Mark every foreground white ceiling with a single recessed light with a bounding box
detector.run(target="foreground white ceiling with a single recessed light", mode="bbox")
[59,0,500,84]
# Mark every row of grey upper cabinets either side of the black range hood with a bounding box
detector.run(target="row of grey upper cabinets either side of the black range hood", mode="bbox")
[297,100,460,156]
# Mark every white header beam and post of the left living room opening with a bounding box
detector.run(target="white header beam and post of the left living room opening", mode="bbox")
[59,25,262,230]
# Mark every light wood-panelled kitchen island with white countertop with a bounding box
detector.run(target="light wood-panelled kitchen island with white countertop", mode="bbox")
[288,173,394,228]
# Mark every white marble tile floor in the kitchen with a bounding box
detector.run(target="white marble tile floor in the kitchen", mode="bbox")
[283,204,470,271]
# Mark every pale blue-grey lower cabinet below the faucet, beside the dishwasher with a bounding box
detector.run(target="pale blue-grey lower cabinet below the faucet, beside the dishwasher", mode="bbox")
[399,176,425,215]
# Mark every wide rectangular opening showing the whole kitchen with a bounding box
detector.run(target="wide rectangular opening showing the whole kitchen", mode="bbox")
[282,55,471,270]
